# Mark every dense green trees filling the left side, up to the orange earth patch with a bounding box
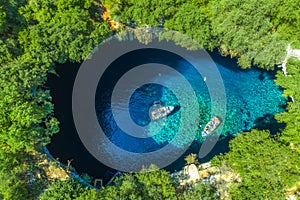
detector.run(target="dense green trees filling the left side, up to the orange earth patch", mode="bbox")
[0,0,110,199]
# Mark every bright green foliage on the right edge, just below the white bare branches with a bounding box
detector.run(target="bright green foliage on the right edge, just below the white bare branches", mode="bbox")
[276,59,300,152]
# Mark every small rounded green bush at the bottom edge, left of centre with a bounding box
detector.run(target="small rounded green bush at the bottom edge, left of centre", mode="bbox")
[40,178,87,200]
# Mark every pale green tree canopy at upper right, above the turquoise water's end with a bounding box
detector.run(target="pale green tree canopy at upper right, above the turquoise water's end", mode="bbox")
[210,0,289,69]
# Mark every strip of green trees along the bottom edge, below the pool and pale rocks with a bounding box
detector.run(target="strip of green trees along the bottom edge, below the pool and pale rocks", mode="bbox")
[41,167,218,200]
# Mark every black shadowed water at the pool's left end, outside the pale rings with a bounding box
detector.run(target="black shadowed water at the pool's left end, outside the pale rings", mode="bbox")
[46,63,115,182]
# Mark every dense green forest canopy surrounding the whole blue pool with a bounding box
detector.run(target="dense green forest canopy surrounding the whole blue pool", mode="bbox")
[0,0,300,199]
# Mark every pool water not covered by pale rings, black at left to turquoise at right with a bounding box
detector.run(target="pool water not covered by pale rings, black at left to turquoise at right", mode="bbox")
[47,49,286,181]
